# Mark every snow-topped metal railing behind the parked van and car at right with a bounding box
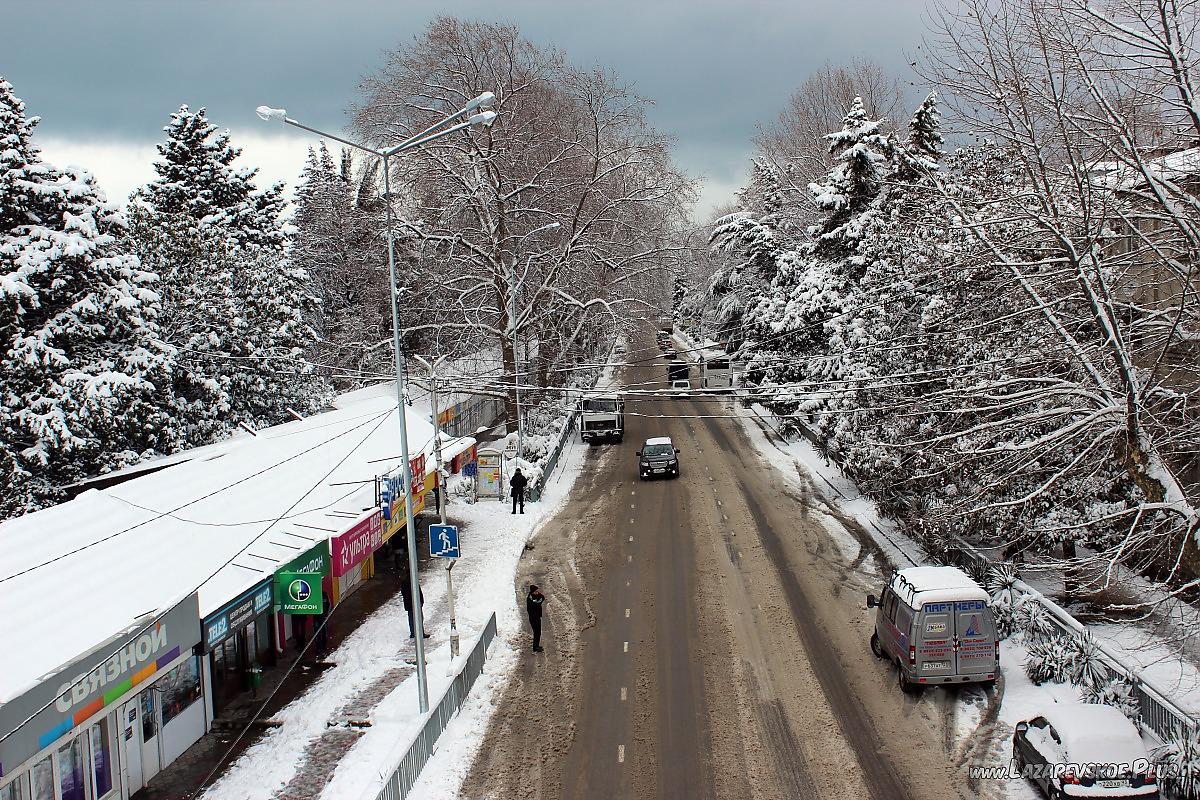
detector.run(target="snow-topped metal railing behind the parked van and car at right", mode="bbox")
[940,539,1200,742]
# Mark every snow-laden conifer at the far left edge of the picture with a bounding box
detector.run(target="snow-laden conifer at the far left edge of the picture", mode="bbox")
[0,79,176,516]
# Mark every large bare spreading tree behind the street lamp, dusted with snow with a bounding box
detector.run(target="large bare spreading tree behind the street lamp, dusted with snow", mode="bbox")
[355,18,691,423]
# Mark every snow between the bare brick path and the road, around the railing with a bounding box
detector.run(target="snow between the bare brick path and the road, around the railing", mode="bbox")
[322,429,587,800]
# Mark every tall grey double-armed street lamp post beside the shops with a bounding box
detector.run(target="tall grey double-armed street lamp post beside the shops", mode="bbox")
[256,91,496,714]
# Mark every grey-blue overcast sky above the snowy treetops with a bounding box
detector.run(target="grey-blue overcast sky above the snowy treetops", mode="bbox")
[0,0,925,216]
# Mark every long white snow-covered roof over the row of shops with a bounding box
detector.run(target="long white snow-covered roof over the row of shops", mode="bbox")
[0,385,451,703]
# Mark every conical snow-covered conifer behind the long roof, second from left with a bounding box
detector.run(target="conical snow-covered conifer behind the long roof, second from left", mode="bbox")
[127,106,325,445]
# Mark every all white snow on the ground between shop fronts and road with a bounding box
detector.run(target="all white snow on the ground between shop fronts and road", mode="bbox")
[204,431,586,800]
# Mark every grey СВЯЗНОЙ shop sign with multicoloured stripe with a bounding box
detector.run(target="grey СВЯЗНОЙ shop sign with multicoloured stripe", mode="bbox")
[0,593,199,777]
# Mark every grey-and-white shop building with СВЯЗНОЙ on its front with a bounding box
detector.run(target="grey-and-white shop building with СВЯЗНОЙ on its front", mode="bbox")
[0,593,206,800]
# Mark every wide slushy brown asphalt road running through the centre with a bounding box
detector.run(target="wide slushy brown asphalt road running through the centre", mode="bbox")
[462,344,995,800]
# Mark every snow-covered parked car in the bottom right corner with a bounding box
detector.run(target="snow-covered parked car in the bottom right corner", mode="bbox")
[1013,703,1159,800]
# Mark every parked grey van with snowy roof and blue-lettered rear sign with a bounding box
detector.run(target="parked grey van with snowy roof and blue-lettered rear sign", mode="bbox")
[866,566,1000,692]
